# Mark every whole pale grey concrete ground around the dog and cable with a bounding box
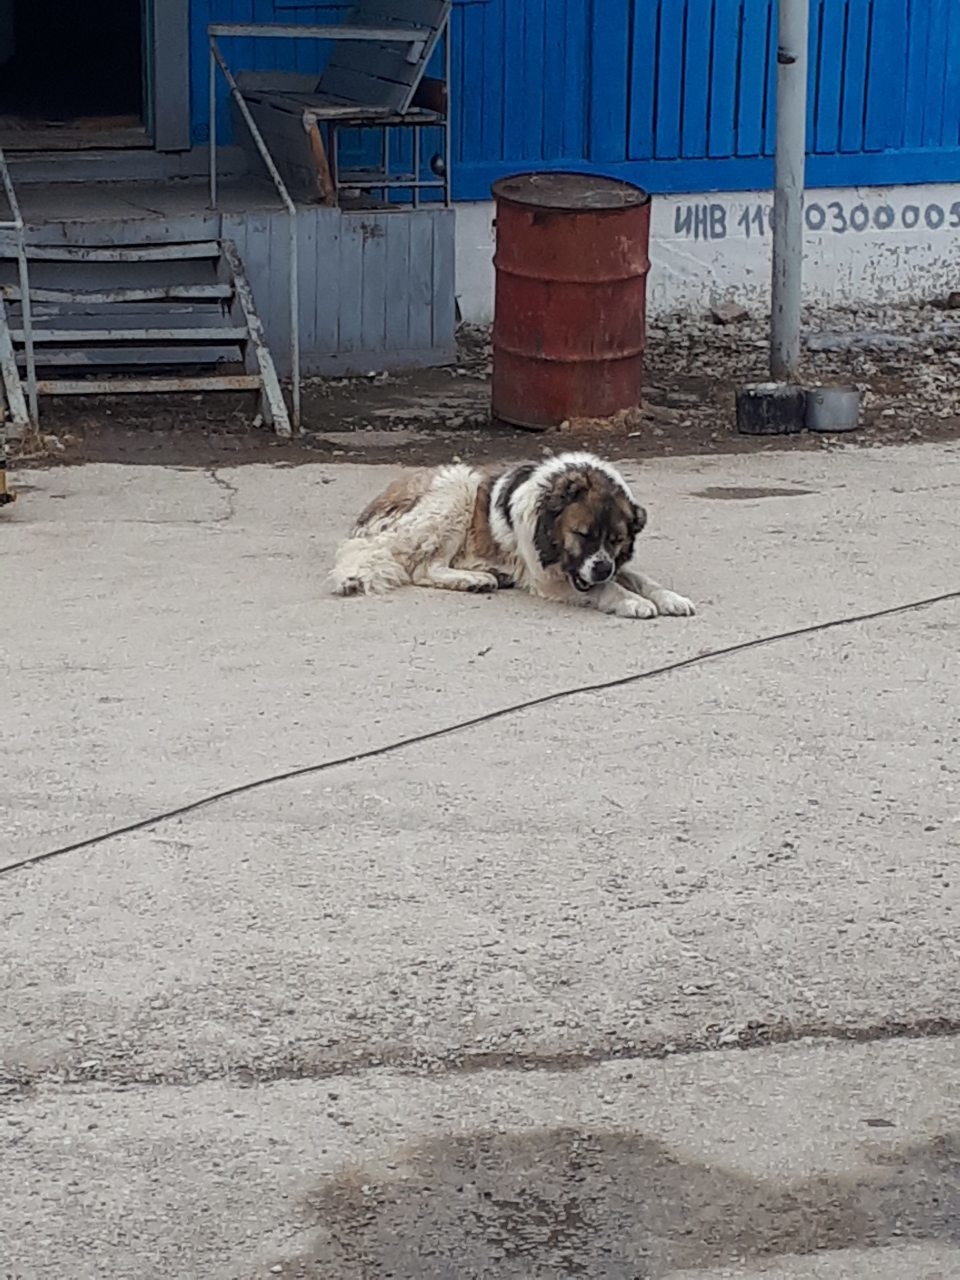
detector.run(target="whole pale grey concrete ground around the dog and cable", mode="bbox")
[0,444,960,1280]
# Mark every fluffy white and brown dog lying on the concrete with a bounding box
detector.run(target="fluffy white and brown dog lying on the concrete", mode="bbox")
[330,453,694,618]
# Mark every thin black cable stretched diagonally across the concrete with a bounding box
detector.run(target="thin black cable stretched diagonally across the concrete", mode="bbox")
[0,591,960,876]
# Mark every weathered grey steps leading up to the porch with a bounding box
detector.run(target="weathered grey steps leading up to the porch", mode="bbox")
[0,232,291,436]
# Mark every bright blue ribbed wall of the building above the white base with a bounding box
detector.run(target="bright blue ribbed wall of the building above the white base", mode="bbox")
[193,0,960,200]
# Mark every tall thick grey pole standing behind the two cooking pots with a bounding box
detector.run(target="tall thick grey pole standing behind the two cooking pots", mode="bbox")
[771,0,810,381]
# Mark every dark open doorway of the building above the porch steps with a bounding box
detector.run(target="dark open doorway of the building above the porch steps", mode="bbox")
[0,0,150,151]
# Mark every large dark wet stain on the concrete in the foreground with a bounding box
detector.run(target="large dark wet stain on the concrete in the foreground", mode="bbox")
[273,1129,960,1280]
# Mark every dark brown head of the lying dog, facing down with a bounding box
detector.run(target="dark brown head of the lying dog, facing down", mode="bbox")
[534,460,646,591]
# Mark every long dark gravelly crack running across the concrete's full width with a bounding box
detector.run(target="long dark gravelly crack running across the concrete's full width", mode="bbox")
[0,1016,960,1102]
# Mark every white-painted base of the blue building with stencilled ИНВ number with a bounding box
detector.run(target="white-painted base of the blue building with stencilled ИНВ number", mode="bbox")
[457,184,960,324]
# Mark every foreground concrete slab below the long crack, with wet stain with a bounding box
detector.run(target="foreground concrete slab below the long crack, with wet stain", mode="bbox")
[0,1042,960,1280]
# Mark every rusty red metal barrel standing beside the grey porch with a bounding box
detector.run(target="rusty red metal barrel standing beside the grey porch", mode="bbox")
[492,173,650,430]
